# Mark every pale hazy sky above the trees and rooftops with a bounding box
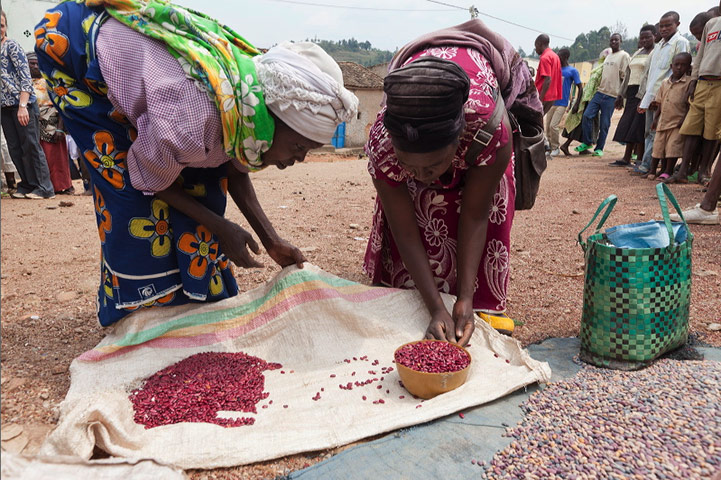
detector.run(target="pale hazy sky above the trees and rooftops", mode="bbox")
[181,0,718,53]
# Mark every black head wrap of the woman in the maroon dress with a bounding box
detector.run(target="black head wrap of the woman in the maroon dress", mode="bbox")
[383,57,470,153]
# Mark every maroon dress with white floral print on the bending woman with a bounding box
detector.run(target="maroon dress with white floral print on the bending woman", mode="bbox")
[363,47,516,312]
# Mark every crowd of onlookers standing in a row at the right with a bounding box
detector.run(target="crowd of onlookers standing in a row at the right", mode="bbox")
[535,6,721,224]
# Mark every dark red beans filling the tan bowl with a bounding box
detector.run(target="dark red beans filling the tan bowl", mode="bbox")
[384,341,471,373]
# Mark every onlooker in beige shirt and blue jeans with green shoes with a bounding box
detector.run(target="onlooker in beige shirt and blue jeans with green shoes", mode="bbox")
[576,33,631,157]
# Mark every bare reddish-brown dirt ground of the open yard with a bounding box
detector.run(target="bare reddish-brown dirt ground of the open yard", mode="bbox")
[0,123,721,479]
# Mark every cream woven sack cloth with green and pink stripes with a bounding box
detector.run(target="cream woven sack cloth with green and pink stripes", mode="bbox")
[41,264,551,468]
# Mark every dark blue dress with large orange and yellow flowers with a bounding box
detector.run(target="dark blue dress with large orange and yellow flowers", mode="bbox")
[35,2,238,326]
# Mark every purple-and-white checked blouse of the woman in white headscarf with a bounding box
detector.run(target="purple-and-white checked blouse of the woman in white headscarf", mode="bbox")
[96,19,247,194]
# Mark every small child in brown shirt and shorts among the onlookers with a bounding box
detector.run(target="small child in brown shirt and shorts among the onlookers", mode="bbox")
[647,52,691,181]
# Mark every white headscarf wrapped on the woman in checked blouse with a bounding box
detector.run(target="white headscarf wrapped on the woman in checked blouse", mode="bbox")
[253,42,358,144]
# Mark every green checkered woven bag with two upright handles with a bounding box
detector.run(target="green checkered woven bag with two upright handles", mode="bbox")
[578,184,693,370]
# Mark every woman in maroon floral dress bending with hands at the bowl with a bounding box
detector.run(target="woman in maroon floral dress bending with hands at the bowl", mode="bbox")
[364,46,515,344]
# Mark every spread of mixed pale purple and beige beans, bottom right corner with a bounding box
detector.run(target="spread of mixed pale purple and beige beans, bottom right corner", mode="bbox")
[476,359,721,480]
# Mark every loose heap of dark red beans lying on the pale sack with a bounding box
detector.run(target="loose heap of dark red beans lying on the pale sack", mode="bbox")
[129,352,280,429]
